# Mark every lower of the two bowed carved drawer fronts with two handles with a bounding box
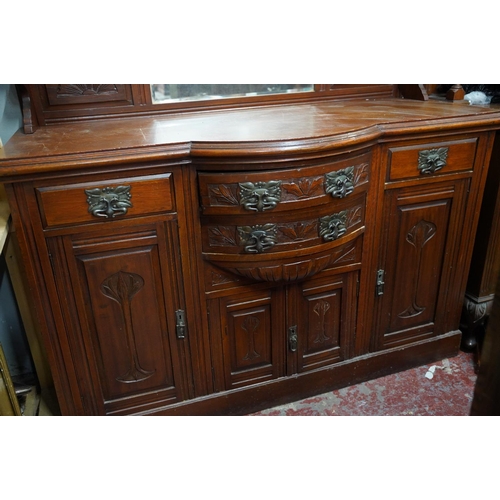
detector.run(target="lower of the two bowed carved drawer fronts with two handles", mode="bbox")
[202,194,365,257]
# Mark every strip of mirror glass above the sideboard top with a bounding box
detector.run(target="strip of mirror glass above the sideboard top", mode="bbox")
[151,83,314,104]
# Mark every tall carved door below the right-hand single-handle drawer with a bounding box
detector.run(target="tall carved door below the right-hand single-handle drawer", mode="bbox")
[372,179,469,349]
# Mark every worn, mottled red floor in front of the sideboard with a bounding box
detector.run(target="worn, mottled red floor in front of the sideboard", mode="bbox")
[253,352,477,416]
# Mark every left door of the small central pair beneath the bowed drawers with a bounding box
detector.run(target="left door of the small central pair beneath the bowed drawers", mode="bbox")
[209,288,285,390]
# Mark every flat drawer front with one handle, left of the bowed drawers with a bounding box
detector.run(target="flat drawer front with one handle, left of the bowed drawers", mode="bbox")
[36,173,175,227]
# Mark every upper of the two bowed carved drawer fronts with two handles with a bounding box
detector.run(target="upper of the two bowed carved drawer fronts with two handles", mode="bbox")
[198,154,371,215]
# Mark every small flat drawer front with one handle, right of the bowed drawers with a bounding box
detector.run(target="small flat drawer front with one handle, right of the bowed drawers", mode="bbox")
[388,137,478,181]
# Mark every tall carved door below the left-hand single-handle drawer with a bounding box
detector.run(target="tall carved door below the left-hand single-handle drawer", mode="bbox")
[48,222,189,414]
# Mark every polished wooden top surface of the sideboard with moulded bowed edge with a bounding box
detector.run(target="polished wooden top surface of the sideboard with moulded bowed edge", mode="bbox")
[0,98,500,179]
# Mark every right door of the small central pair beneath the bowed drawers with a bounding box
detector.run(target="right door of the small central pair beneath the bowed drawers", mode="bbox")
[288,272,358,374]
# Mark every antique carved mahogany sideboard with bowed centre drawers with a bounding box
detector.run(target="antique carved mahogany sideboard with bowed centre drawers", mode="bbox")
[0,85,500,415]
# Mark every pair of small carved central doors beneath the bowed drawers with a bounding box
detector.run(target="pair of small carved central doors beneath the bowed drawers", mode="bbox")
[209,271,358,390]
